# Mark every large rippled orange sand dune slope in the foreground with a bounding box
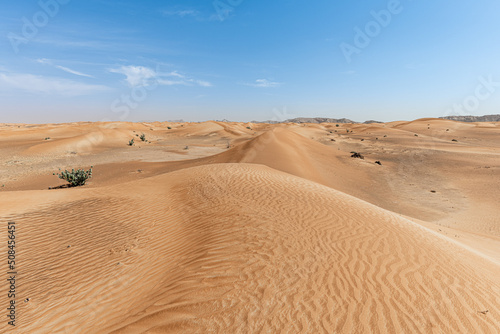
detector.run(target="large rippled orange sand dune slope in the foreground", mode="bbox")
[0,164,500,333]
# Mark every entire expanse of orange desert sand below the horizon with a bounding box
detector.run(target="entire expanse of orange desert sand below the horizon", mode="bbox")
[0,119,500,333]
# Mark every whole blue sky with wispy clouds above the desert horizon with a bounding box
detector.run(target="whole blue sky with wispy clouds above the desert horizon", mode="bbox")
[0,0,500,123]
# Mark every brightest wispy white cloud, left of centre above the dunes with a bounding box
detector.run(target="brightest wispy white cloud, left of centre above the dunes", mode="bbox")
[109,65,212,87]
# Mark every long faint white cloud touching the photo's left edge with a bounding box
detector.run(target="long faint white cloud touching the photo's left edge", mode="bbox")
[0,73,110,96]
